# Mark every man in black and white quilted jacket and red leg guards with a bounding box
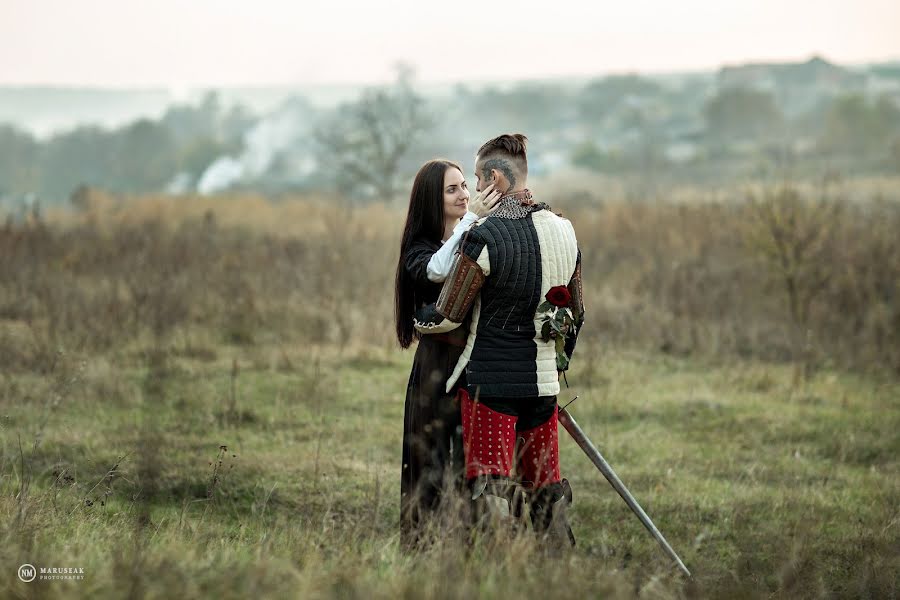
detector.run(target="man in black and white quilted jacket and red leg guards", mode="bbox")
[416,134,584,545]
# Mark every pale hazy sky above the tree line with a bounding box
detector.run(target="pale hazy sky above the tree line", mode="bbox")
[0,0,900,88]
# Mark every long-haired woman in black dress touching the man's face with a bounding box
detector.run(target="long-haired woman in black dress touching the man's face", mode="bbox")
[394,160,500,547]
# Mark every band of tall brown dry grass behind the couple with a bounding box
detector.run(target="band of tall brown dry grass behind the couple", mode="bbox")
[8,182,900,374]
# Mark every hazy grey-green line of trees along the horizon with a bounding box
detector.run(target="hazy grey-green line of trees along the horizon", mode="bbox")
[0,71,900,202]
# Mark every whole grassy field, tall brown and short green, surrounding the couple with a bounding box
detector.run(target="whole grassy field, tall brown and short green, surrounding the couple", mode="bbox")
[0,185,900,598]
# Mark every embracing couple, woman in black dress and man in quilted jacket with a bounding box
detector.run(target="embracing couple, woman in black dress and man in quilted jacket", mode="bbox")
[395,134,584,548]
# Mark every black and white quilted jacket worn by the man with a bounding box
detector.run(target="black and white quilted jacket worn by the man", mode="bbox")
[416,190,584,398]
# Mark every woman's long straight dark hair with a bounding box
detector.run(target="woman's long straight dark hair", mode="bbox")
[394,159,462,348]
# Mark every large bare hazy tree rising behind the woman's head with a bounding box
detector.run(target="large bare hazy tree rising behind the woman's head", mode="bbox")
[315,66,434,200]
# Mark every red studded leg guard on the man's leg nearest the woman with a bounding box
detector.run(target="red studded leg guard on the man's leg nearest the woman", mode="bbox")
[459,389,516,479]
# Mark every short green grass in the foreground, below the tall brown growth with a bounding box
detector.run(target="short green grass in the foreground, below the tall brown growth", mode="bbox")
[0,334,900,599]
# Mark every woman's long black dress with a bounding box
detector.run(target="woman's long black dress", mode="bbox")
[400,240,467,547]
